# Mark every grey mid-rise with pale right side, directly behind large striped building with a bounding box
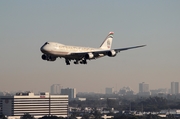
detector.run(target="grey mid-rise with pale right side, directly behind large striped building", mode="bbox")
[61,88,76,100]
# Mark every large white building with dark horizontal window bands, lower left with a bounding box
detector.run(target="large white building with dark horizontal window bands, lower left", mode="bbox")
[0,92,68,119]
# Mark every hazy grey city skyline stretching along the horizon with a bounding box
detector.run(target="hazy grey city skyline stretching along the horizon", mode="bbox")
[0,82,180,95]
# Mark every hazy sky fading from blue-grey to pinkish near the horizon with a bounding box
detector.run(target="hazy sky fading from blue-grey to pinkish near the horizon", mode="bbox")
[0,0,180,92]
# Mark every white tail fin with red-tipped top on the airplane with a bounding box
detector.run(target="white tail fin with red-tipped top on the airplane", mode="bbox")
[100,32,114,50]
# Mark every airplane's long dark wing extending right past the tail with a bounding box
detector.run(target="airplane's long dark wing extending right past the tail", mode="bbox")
[71,45,146,58]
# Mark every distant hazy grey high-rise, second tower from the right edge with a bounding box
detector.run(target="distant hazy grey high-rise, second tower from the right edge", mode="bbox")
[139,82,150,96]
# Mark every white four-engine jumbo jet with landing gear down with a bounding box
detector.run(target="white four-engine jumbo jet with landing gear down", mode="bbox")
[40,32,146,65]
